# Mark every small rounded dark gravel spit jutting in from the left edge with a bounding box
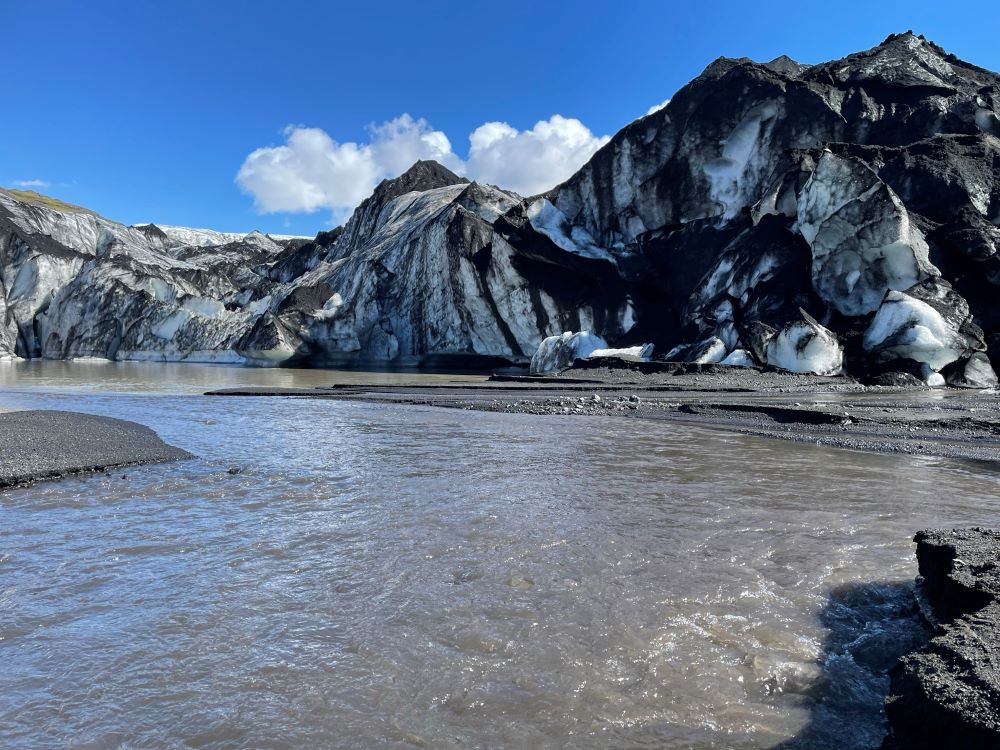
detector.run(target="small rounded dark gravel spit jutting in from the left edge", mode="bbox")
[0,410,193,491]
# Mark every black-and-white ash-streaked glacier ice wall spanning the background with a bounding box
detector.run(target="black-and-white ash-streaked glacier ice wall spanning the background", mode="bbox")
[0,32,1000,378]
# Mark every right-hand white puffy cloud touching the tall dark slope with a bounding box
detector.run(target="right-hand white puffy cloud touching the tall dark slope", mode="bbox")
[466,115,610,195]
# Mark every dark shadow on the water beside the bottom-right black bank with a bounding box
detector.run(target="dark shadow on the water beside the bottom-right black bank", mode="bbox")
[774,582,931,750]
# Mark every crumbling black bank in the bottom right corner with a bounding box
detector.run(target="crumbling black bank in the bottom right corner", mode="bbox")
[883,528,1000,750]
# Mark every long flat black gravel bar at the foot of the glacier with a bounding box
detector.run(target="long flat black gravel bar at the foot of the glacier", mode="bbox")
[206,366,1000,462]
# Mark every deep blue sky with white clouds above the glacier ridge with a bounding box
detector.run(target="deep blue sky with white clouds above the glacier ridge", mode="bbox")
[0,0,1000,234]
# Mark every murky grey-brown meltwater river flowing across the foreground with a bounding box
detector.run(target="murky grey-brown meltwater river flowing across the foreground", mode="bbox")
[0,363,1000,750]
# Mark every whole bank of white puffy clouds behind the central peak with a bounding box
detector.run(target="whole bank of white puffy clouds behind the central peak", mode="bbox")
[236,114,608,221]
